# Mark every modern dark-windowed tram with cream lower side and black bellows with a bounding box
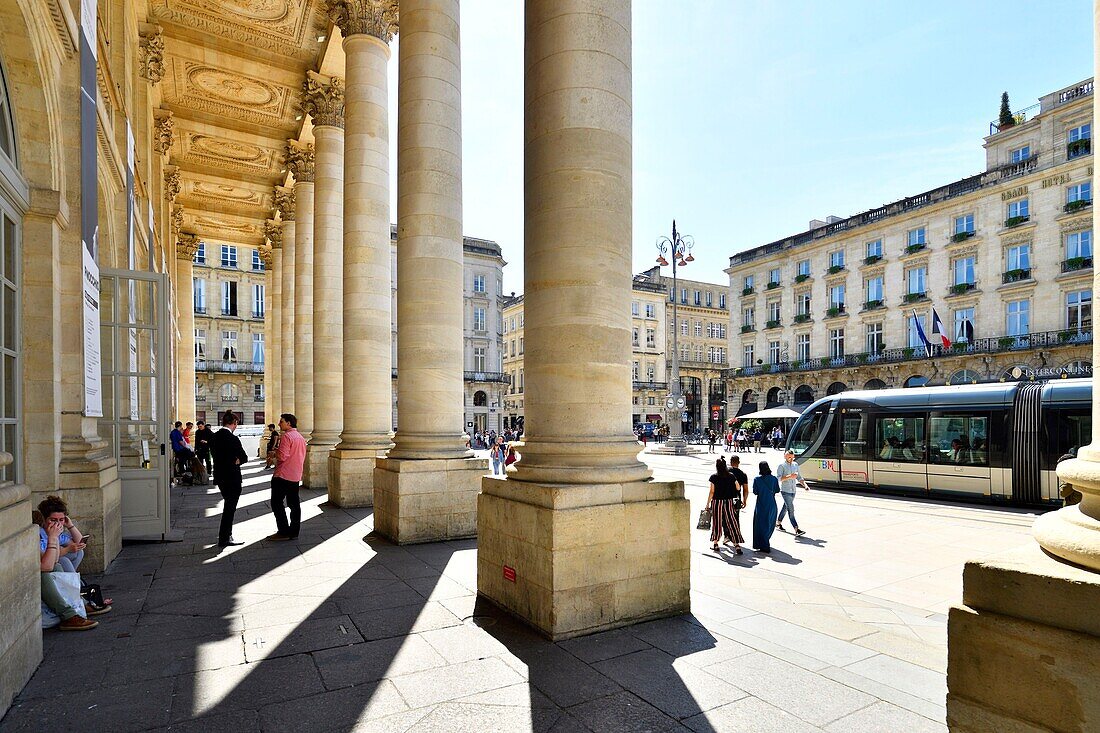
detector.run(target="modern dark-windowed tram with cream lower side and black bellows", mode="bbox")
[787,380,1092,506]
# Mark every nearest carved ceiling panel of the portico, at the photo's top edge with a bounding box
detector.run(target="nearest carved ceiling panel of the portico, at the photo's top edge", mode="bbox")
[152,0,327,61]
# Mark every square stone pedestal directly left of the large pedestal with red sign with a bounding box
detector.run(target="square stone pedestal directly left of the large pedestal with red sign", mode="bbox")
[374,458,488,545]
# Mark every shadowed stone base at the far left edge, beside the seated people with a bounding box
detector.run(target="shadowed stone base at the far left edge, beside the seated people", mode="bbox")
[0,485,42,716]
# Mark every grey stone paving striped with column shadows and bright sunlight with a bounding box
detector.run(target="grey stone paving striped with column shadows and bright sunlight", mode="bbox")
[0,455,1031,733]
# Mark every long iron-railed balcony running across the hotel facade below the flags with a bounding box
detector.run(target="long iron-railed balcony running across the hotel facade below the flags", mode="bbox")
[722,325,1092,379]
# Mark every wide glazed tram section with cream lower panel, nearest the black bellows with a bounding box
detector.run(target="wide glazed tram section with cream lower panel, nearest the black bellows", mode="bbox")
[928,412,990,497]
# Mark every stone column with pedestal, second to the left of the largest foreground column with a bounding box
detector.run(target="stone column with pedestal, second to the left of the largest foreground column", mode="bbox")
[329,0,397,506]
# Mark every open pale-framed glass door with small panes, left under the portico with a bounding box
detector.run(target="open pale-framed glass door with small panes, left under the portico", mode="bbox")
[99,270,171,539]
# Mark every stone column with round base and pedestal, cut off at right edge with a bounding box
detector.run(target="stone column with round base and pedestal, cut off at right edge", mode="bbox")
[947,7,1100,733]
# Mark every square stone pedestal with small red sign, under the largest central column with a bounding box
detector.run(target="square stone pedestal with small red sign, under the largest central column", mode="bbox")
[477,478,691,641]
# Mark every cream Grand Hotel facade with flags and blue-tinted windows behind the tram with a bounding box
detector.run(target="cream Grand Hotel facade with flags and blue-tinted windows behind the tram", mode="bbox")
[726,79,1093,409]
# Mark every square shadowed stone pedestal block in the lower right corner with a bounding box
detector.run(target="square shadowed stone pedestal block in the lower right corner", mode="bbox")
[947,544,1100,733]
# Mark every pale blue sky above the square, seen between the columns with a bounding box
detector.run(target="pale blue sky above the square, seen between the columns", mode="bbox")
[391,0,1092,293]
